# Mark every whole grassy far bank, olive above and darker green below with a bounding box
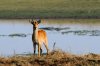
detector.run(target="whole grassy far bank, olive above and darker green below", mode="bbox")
[0,0,100,18]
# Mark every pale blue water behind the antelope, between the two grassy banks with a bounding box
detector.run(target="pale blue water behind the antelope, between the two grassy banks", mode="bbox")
[0,19,100,56]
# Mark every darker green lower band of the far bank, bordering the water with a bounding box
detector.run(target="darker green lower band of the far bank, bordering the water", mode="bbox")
[0,10,100,19]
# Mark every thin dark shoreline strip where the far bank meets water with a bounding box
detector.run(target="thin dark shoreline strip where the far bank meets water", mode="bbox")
[0,16,100,19]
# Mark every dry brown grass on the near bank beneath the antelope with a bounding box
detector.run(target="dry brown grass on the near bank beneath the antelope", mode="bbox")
[0,51,100,66]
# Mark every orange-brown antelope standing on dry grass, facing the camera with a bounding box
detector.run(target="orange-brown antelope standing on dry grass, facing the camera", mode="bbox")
[29,19,48,57]
